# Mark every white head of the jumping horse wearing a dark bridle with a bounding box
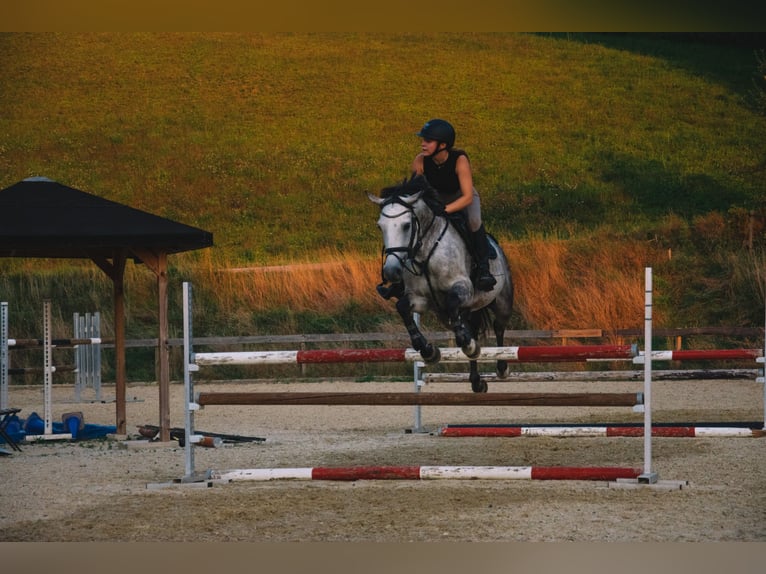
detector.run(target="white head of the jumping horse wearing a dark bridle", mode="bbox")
[367,176,431,283]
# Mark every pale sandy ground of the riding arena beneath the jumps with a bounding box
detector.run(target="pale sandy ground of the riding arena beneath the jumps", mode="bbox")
[0,380,766,542]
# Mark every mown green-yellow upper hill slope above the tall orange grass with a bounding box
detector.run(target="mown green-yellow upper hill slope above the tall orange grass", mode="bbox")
[0,33,766,258]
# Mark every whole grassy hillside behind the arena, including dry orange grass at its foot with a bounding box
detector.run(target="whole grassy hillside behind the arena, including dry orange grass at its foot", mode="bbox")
[0,33,766,382]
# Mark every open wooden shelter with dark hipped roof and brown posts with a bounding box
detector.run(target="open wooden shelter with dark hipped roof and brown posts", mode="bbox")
[0,177,213,441]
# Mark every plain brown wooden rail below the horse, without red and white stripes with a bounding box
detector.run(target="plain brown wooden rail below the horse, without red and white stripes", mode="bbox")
[196,392,644,407]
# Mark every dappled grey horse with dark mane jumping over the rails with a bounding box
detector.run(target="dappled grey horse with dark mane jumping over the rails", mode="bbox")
[367,175,514,393]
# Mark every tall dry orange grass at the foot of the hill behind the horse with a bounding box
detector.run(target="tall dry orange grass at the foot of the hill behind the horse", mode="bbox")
[177,238,663,338]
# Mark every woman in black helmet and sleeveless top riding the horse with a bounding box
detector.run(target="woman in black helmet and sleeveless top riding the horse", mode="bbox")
[412,119,496,291]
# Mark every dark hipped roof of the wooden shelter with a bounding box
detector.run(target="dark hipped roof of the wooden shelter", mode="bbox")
[0,178,213,258]
